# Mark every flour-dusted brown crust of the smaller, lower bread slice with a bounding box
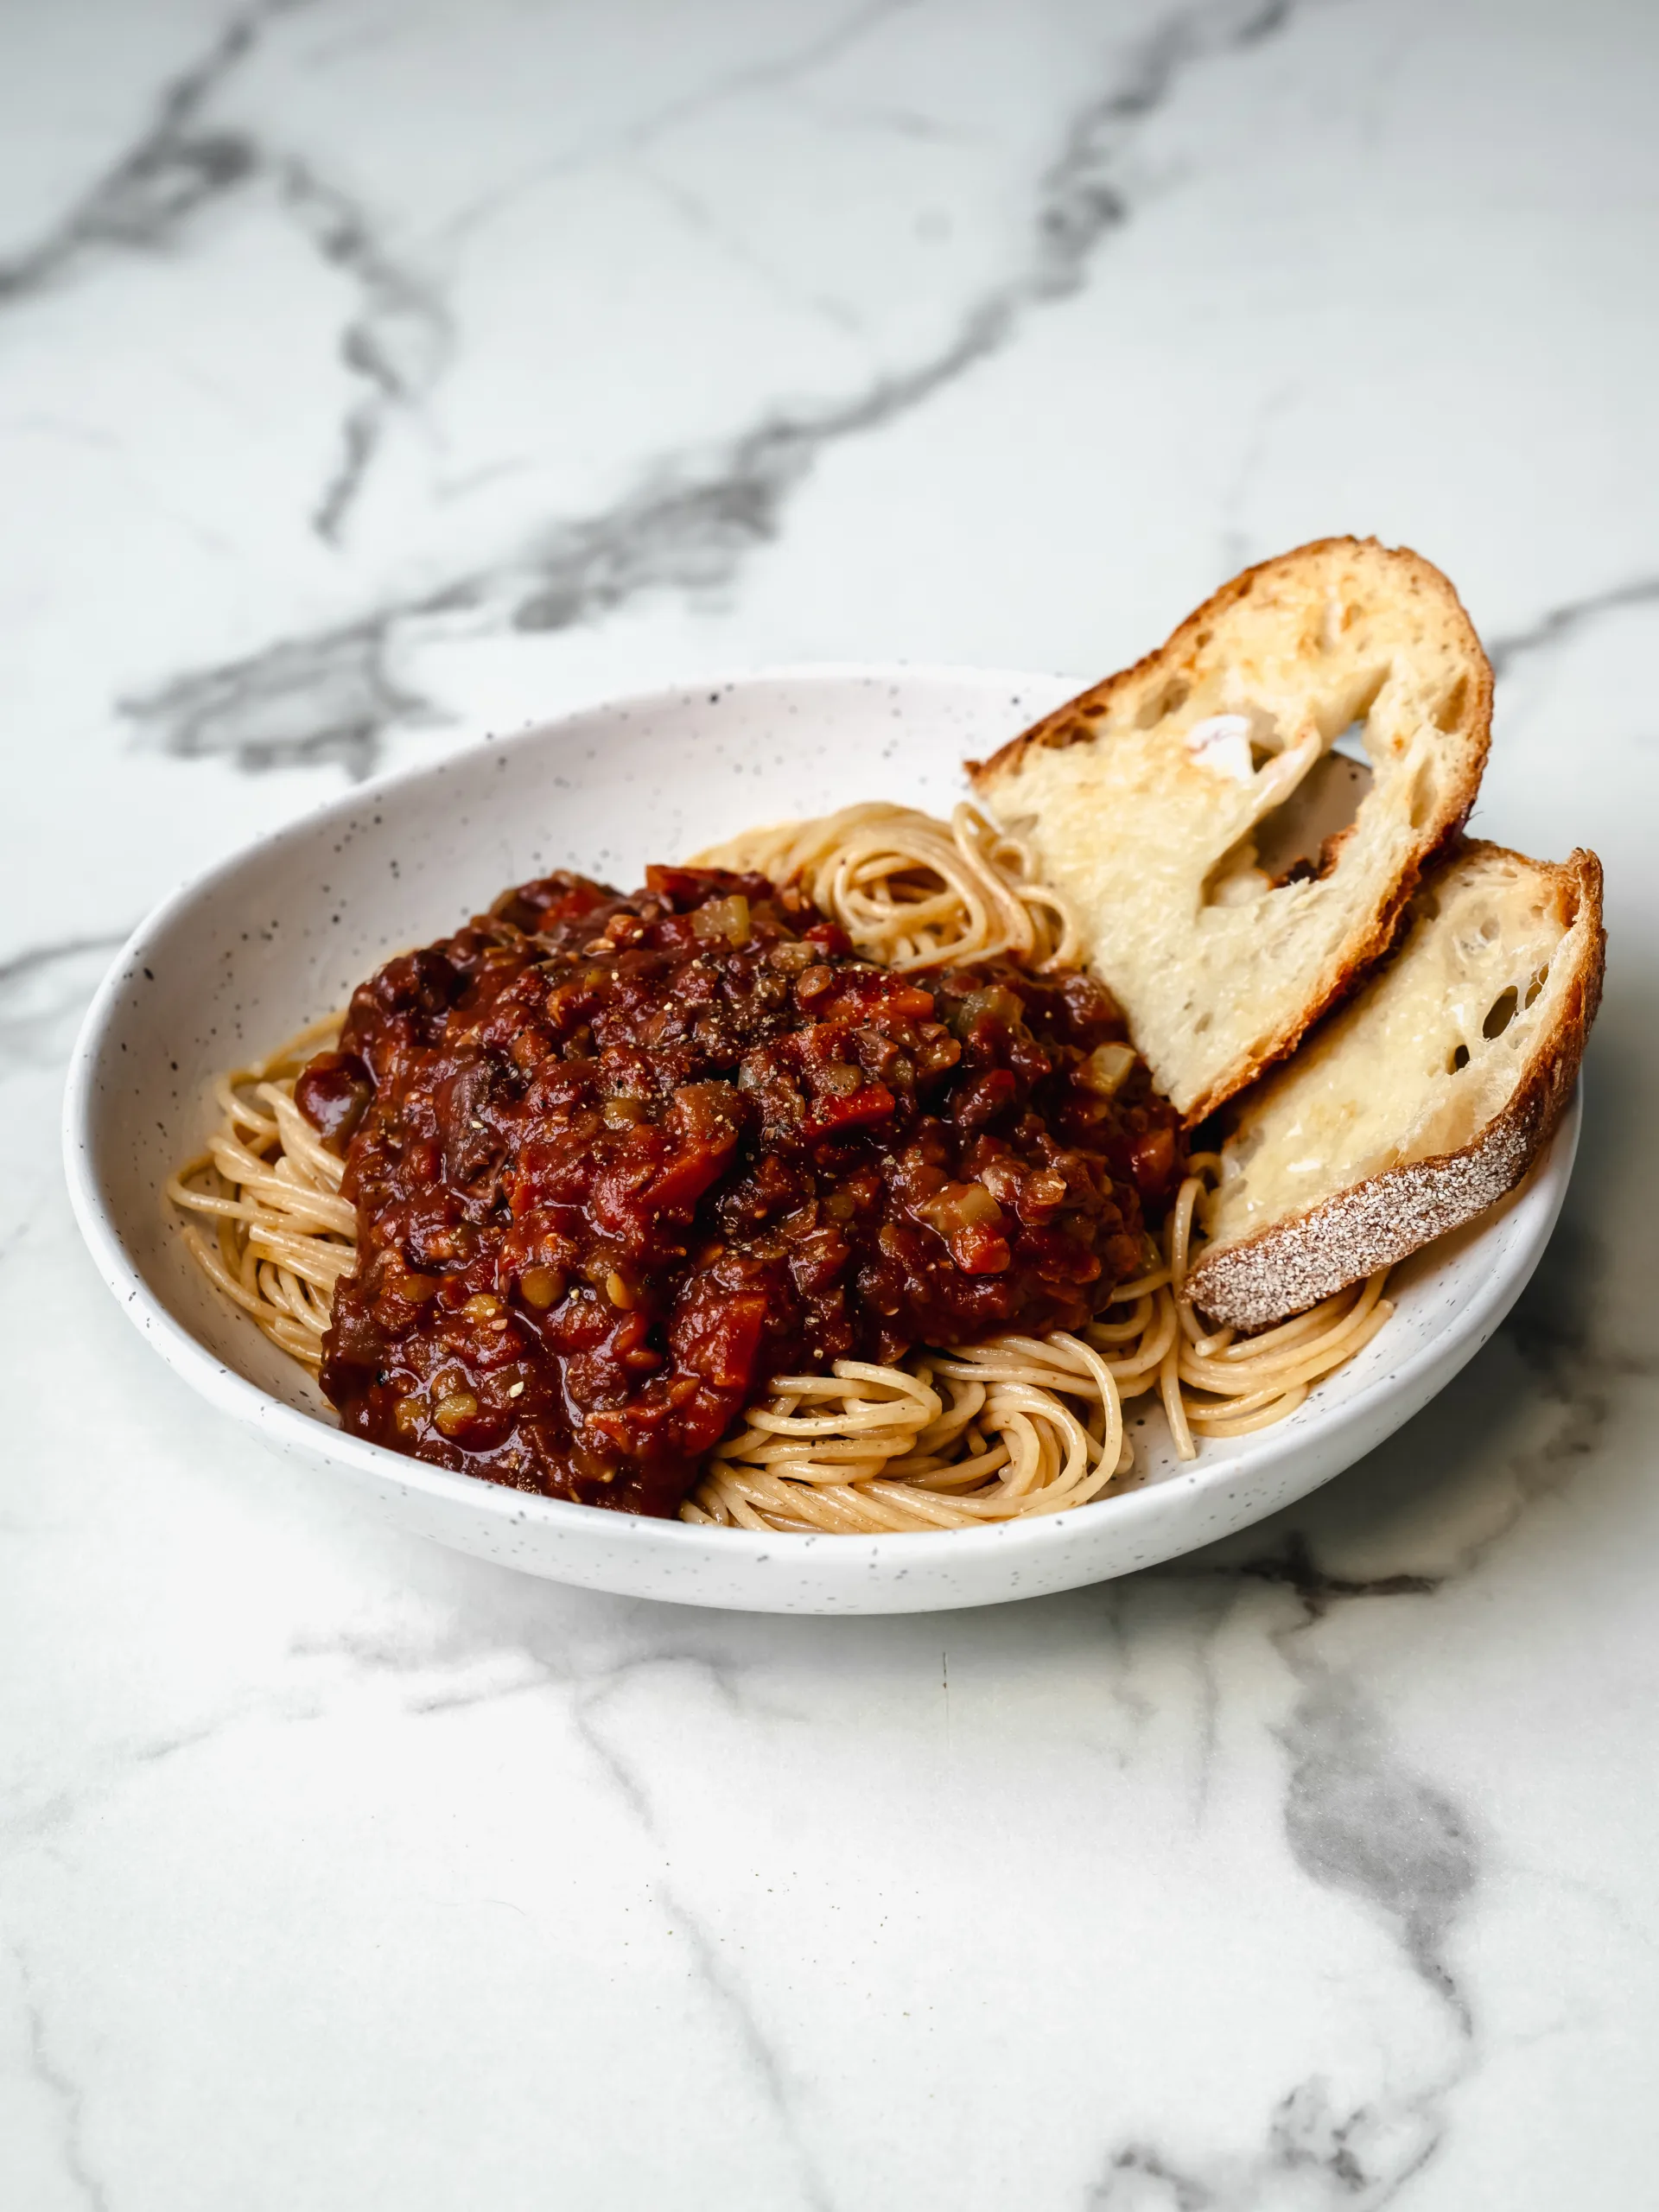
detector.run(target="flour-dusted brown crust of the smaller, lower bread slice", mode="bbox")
[1181,841,1606,1332]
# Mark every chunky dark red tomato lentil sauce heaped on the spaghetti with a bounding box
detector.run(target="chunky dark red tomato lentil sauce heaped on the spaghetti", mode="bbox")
[294,868,1181,1516]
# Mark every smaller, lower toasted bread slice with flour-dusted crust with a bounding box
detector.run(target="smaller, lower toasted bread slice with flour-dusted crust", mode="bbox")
[1184,841,1606,1330]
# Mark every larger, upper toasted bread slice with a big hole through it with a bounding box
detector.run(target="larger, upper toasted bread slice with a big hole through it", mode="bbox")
[969,537,1491,1122]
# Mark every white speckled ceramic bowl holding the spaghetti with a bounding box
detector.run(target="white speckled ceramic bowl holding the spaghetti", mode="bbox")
[64,668,1577,1612]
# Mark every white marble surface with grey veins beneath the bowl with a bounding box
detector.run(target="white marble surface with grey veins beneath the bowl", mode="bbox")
[0,0,1659,2212]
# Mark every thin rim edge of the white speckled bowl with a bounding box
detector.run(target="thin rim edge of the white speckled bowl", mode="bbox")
[62,661,1581,1595]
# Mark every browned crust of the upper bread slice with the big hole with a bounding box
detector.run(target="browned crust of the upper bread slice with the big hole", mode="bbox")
[964,537,1493,1128]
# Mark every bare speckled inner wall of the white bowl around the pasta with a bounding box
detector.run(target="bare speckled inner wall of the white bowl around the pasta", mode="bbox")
[68,668,1571,1583]
